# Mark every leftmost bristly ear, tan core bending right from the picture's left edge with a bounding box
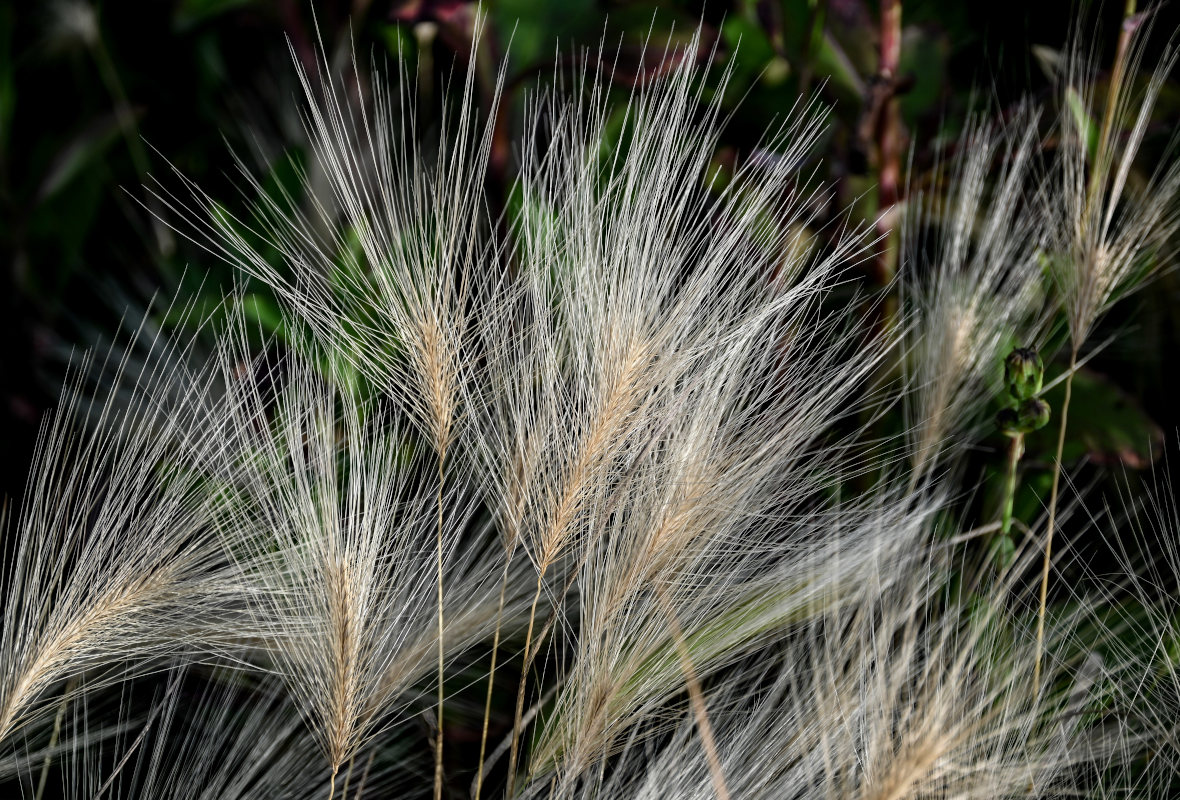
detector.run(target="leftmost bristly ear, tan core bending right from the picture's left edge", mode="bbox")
[0,304,234,755]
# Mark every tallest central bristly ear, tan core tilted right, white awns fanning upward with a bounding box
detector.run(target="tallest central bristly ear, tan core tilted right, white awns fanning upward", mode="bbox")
[472,25,877,594]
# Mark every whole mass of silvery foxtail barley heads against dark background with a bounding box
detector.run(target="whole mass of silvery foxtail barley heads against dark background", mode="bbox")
[0,4,1180,800]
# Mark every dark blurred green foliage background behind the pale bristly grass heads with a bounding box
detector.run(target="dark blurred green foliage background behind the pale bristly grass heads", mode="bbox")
[0,0,1180,561]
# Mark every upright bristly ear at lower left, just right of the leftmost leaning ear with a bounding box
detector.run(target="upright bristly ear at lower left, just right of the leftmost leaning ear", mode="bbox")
[207,313,531,773]
